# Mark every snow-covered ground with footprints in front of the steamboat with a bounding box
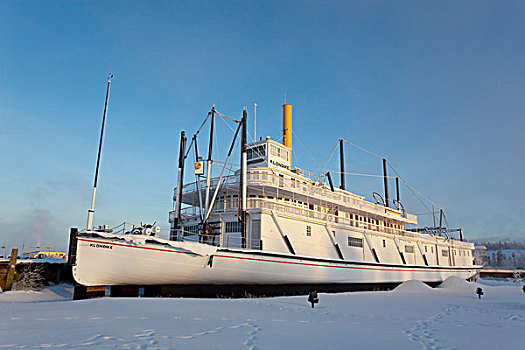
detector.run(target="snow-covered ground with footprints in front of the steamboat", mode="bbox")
[0,279,525,350]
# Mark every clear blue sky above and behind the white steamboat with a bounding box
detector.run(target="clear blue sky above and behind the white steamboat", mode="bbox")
[0,1,525,249]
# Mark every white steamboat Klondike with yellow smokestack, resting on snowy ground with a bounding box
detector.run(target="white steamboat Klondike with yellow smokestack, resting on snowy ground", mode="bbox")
[71,82,480,295]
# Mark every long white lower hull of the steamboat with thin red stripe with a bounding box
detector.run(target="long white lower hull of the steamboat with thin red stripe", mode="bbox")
[73,236,476,286]
